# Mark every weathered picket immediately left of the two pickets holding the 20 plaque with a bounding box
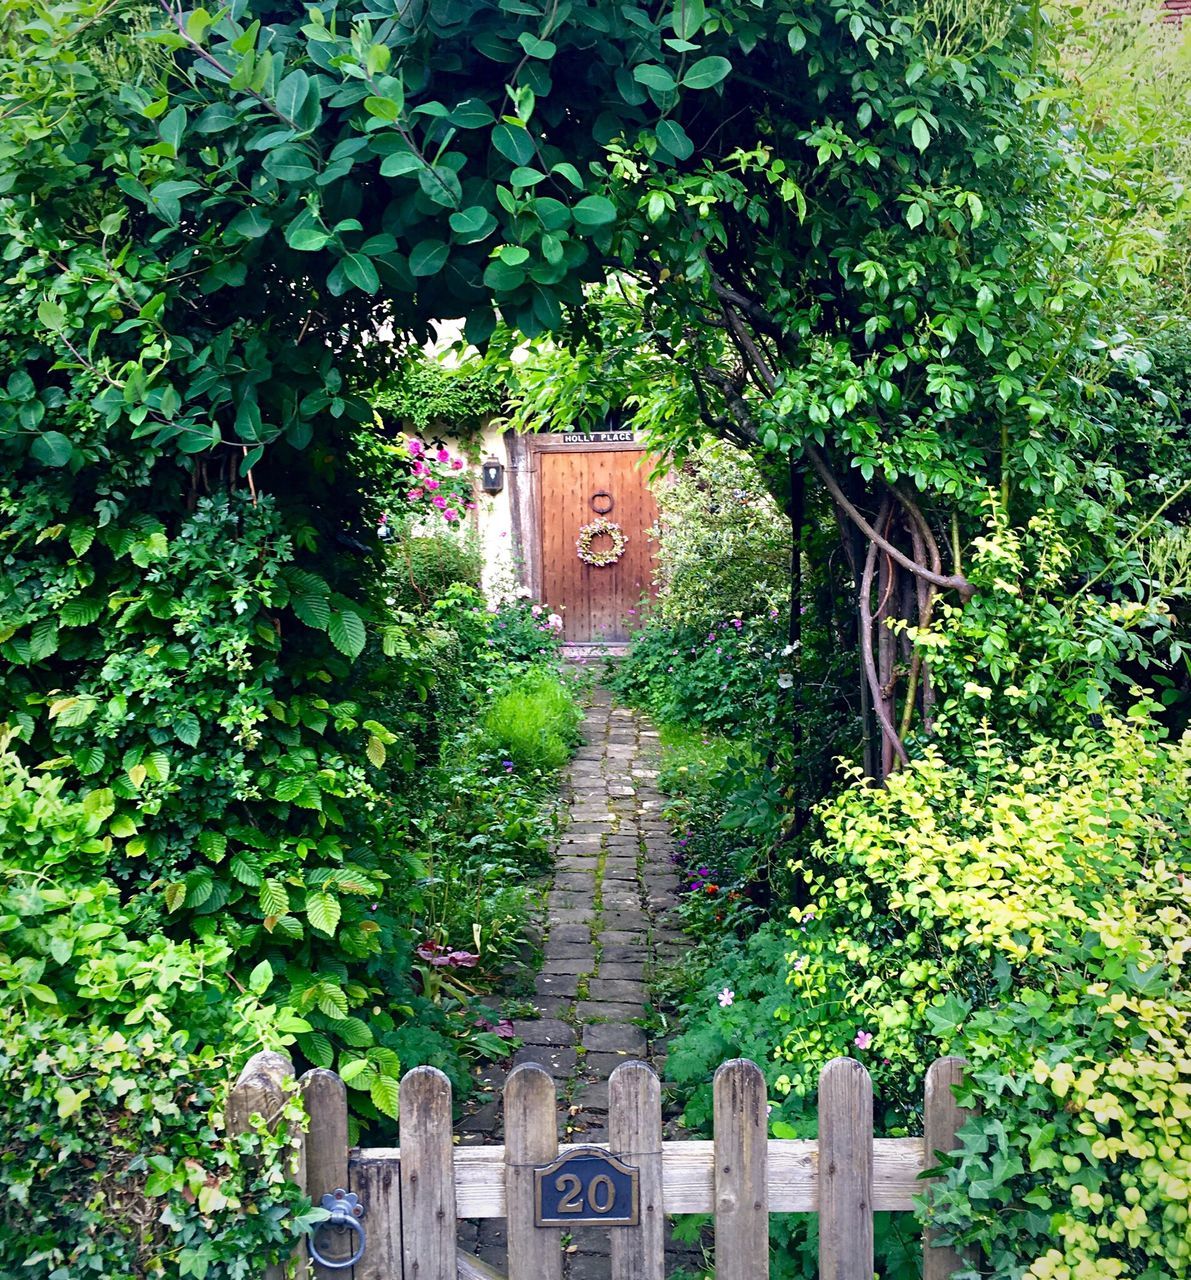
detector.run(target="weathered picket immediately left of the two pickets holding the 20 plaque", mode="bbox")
[398,1066,457,1280]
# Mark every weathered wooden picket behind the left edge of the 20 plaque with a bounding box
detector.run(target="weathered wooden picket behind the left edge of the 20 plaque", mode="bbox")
[505,1062,562,1280]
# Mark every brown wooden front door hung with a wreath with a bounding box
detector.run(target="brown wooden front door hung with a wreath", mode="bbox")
[538,448,657,644]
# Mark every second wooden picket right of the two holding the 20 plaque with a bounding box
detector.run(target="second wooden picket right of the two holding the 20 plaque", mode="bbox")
[818,1057,873,1280]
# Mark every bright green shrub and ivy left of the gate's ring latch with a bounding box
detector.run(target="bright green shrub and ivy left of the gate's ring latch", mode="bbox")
[0,744,310,1280]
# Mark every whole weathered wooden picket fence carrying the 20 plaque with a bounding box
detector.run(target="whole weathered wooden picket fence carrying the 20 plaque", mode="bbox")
[228,1053,966,1280]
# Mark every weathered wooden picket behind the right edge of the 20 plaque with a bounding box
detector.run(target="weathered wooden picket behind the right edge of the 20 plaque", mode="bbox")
[608,1062,666,1280]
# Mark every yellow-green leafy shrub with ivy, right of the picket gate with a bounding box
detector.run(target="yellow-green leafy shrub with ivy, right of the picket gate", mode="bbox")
[667,707,1191,1280]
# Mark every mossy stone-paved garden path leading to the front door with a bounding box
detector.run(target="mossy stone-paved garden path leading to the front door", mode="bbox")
[460,687,695,1280]
